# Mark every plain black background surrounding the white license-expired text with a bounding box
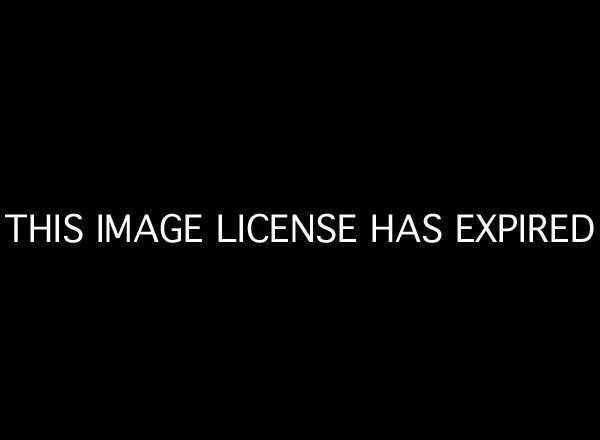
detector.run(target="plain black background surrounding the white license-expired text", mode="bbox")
[1,5,598,433]
